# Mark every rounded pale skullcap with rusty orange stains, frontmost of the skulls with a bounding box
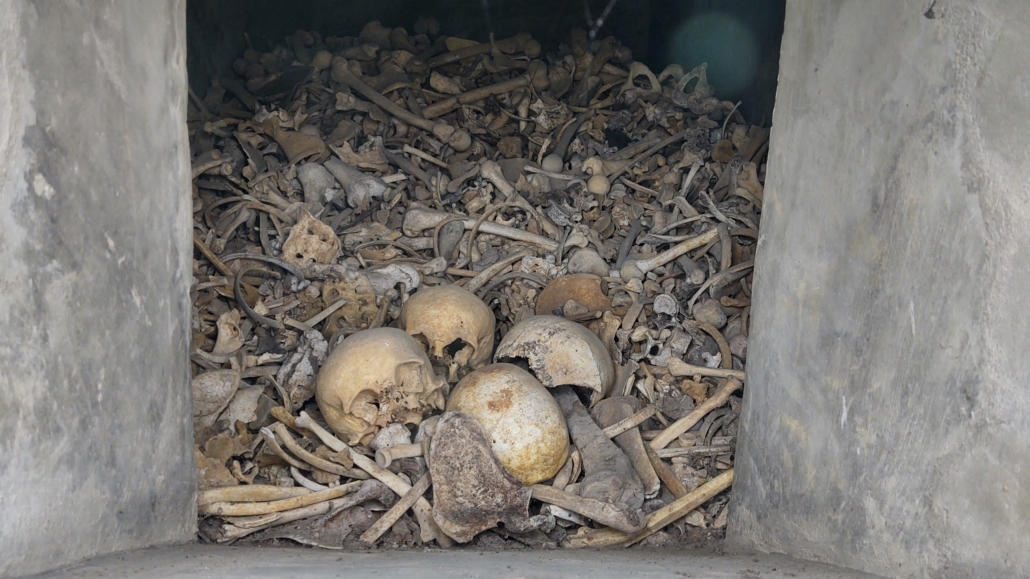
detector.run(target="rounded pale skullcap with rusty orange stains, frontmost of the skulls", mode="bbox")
[447,364,569,485]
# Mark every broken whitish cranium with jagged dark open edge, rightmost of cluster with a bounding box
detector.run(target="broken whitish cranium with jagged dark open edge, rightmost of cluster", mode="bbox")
[493,315,615,405]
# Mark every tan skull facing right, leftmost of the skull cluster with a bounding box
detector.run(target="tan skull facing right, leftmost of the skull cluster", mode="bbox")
[315,328,445,445]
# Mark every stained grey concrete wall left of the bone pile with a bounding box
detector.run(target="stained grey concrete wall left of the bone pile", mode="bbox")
[0,0,196,577]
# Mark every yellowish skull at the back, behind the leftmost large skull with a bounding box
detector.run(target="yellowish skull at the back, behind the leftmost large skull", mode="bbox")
[400,285,494,380]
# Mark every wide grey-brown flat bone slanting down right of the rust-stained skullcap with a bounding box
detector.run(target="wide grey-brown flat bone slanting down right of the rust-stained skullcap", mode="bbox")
[551,386,644,509]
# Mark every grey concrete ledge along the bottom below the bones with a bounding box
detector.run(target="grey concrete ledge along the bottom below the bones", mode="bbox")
[36,545,873,579]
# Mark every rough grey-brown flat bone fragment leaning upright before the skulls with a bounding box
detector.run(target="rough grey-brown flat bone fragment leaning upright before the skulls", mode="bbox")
[430,412,537,543]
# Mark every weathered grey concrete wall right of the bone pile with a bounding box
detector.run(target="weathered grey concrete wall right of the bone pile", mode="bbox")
[729,0,1030,578]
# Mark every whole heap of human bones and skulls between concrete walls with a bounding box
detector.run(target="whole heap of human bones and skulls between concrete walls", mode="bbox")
[188,19,768,548]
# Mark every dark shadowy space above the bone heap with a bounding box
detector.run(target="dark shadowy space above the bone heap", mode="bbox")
[186,0,786,124]
